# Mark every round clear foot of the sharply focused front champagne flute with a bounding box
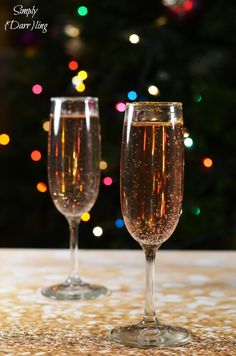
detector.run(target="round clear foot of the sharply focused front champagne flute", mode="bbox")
[111,321,191,348]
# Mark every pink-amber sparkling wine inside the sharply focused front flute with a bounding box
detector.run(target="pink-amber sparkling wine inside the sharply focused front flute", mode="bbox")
[121,121,184,246]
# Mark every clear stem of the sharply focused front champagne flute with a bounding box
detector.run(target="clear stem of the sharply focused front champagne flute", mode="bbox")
[143,248,157,323]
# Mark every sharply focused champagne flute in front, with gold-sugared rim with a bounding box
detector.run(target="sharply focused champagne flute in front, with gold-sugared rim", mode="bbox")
[111,102,190,348]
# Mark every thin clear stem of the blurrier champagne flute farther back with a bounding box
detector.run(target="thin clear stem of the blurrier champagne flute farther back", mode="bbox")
[68,218,80,279]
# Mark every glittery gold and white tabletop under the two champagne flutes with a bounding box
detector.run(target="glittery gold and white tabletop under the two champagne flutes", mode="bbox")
[0,249,236,356]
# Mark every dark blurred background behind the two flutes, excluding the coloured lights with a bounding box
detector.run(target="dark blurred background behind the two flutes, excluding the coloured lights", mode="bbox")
[0,0,236,249]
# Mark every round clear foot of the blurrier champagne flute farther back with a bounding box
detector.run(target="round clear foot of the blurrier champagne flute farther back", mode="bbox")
[41,277,111,300]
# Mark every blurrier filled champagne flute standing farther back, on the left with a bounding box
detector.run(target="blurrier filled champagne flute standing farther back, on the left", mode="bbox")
[42,97,108,300]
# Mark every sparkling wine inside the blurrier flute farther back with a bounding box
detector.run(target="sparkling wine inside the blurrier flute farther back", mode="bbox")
[48,114,100,217]
